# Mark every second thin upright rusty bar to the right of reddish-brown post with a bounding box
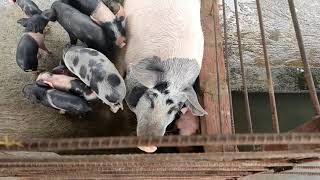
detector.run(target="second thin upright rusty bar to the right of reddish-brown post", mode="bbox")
[234,0,253,133]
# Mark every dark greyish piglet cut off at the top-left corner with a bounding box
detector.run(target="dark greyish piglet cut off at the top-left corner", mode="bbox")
[10,0,42,17]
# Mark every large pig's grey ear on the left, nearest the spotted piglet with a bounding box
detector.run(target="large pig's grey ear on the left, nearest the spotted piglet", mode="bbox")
[130,57,164,88]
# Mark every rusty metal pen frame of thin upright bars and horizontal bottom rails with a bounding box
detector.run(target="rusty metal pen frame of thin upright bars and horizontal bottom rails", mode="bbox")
[0,0,320,179]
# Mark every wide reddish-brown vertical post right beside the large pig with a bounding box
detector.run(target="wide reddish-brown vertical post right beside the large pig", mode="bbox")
[199,0,234,152]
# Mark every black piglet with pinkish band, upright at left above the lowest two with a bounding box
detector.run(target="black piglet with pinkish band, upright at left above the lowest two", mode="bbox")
[16,14,50,72]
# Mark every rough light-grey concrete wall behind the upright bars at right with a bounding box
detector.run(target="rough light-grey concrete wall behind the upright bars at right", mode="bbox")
[221,0,320,92]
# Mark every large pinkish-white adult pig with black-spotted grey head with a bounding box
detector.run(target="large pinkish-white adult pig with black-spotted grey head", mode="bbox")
[124,0,207,143]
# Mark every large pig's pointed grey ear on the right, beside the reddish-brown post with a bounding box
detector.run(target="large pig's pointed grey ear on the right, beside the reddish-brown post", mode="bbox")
[183,87,208,116]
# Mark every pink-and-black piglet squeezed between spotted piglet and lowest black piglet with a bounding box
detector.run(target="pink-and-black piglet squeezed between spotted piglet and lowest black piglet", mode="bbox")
[36,72,97,101]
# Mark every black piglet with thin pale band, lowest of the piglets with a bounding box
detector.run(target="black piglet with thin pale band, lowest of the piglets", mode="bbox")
[23,83,92,115]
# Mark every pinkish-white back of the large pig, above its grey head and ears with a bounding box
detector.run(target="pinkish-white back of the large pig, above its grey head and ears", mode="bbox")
[124,0,204,67]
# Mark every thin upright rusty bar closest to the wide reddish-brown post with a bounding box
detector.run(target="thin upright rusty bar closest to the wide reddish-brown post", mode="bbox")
[222,0,236,134]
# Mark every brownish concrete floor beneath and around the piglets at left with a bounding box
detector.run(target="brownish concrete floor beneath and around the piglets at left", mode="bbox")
[0,0,135,138]
